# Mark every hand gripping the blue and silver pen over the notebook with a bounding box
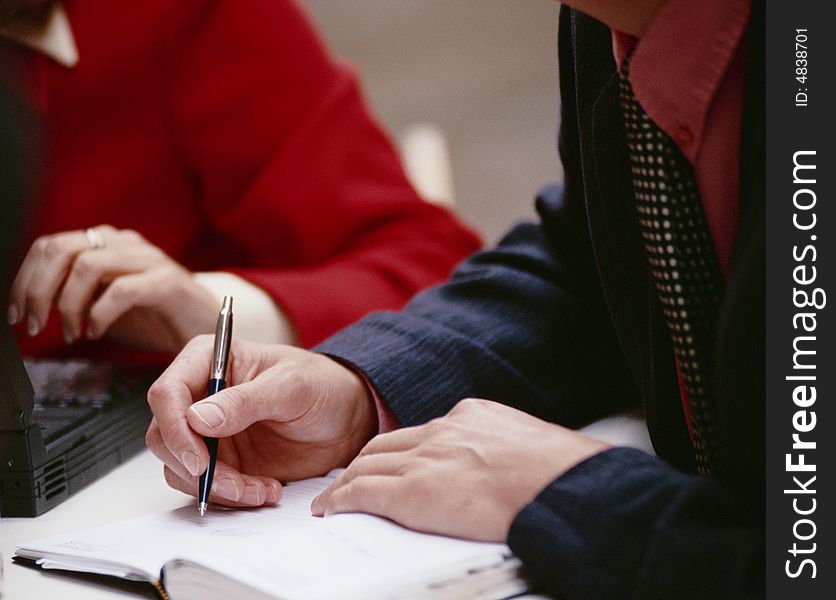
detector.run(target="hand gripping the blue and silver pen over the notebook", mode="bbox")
[146,336,377,506]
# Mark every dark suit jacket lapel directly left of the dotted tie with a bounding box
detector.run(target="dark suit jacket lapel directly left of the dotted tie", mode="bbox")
[572,13,694,470]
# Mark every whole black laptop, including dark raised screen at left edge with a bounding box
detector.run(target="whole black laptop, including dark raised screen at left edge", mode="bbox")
[0,82,162,517]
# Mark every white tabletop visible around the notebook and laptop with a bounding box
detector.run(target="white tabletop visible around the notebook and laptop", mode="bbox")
[0,414,652,600]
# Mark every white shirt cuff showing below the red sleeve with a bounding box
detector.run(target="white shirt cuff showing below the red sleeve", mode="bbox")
[192,271,299,346]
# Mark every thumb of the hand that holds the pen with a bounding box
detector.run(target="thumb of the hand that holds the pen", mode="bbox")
[186,381,306,437]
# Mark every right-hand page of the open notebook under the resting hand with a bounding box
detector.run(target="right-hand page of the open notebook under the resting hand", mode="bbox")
[183,514,513,600]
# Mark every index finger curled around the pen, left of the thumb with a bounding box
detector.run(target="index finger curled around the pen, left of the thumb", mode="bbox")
[148,335,214,475]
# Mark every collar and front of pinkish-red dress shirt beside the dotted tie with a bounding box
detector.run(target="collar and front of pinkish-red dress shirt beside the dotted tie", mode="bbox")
[613,0,751,426]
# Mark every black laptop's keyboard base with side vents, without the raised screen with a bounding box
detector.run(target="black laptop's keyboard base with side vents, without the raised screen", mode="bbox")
[0,324,161,517]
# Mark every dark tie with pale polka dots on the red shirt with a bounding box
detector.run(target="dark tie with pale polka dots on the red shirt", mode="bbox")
[620,58,723,475]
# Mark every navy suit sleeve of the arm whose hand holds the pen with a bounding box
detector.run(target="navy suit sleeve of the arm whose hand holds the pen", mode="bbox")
[315,188,636,425]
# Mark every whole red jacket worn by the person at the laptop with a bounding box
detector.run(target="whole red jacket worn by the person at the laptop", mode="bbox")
[0,0,478,355]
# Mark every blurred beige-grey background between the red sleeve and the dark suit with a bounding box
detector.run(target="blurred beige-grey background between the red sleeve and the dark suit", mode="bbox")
[301,0,561,243]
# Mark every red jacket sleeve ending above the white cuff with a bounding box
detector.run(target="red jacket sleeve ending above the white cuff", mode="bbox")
[163,0,479,346]
